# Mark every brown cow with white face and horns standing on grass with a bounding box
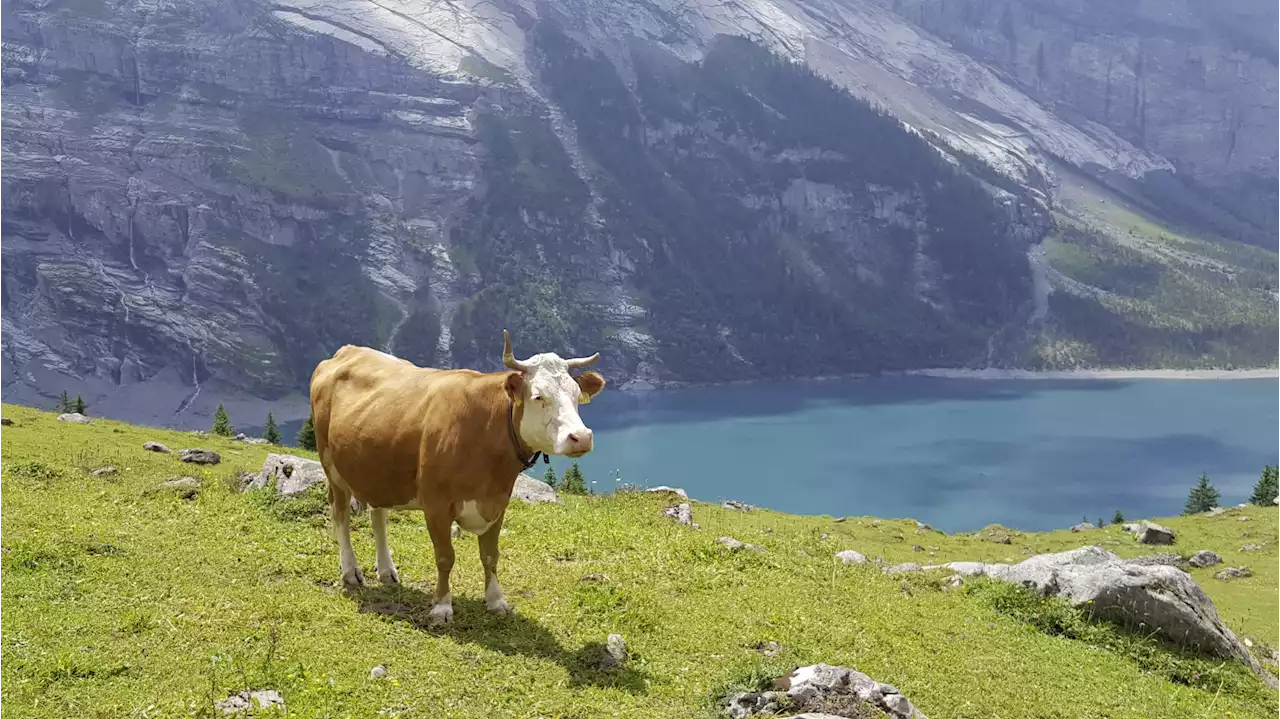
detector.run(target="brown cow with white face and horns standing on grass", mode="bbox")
[311,330,604,623]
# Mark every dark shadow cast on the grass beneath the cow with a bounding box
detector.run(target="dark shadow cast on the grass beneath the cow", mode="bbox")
[343,585,649,693]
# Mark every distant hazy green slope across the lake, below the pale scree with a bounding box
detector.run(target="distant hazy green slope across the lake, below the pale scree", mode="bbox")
[1038,167,1280,368]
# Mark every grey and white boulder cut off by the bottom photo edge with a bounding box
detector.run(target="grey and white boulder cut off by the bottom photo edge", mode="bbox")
[728,664,928,719]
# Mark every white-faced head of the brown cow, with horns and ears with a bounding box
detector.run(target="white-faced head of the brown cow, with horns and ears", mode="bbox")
[502,330,604,457]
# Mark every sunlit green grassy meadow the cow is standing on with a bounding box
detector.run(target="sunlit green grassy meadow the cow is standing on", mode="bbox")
[0,406,1280,719]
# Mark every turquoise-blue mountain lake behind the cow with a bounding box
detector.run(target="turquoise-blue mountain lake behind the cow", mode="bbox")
[282,377,1280,531]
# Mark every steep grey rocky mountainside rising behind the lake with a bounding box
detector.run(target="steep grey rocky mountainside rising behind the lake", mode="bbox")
[0,0,1280,426]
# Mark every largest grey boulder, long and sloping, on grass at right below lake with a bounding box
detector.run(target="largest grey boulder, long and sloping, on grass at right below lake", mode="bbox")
[926,546,1260,672]
